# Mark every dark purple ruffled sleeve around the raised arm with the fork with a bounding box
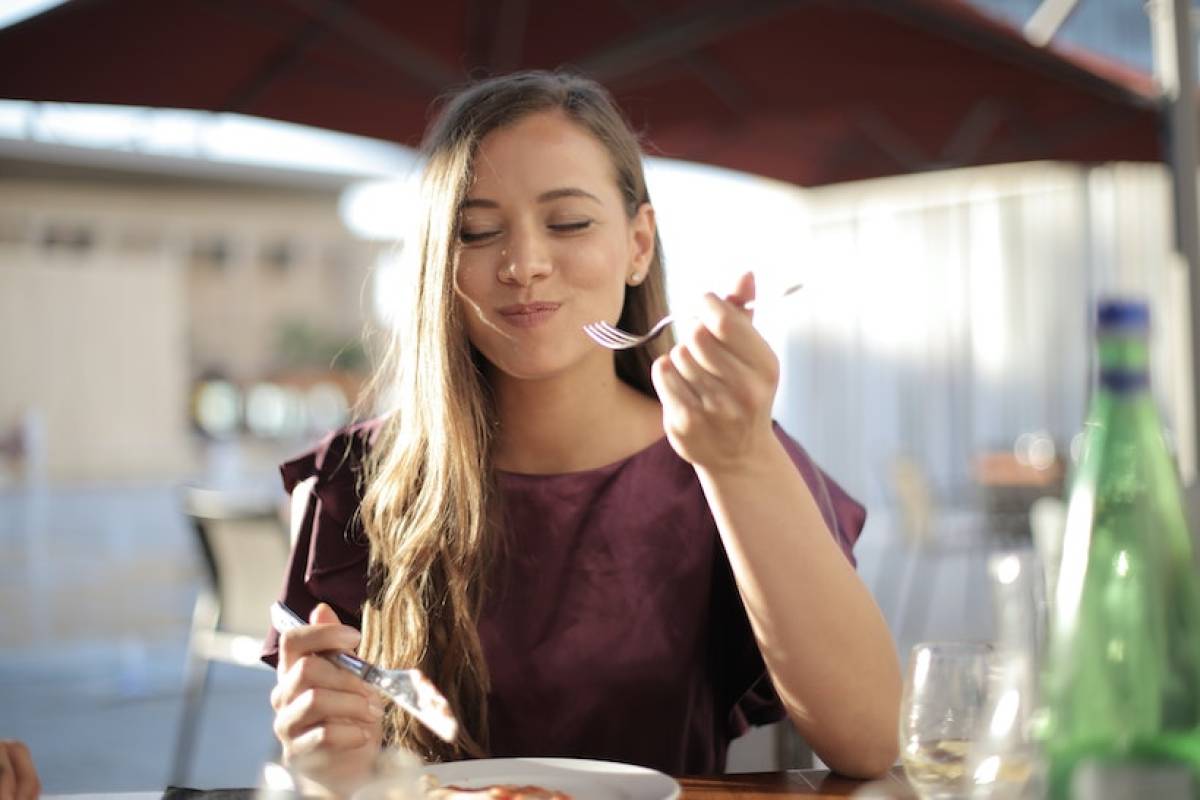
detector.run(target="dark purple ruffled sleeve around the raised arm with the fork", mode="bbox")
[713,423,866,739]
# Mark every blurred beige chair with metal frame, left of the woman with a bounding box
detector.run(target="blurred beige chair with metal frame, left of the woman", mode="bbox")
[170,488,289,786]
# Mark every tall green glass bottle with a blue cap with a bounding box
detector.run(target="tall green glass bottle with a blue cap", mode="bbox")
[1042,300,1200,800]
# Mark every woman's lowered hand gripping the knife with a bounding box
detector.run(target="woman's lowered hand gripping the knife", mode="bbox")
[271,603,384,794]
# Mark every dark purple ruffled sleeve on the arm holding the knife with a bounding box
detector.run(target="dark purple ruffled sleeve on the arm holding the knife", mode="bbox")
[262,420,380,667]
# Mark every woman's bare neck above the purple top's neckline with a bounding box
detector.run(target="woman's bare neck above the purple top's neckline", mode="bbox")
[493,359,662,475]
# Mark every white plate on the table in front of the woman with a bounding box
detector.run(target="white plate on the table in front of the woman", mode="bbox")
[425,758,679,800]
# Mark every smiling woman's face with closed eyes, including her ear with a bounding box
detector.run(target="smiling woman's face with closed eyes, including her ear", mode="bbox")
[457,112,654,379]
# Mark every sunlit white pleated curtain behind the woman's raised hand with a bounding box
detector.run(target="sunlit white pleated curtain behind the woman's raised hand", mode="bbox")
[764,163,1189,507]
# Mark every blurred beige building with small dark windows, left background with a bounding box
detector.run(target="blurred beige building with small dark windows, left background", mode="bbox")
[0,171,372,481]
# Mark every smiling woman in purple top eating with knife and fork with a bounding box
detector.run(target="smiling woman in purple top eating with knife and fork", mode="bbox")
[266,72,900,776]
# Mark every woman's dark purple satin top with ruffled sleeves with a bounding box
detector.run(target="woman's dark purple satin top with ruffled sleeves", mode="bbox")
[263,420,866,775]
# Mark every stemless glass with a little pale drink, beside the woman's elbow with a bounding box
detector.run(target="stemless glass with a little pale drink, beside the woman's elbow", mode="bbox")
[900,642,994,799]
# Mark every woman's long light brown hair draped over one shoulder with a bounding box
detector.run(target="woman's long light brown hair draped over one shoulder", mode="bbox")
[361,72,671,759]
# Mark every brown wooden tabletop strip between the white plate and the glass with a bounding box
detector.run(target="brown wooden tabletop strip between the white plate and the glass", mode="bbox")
[679,766,916,800]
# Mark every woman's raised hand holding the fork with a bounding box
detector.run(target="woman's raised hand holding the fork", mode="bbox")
[650,272,779,471]
